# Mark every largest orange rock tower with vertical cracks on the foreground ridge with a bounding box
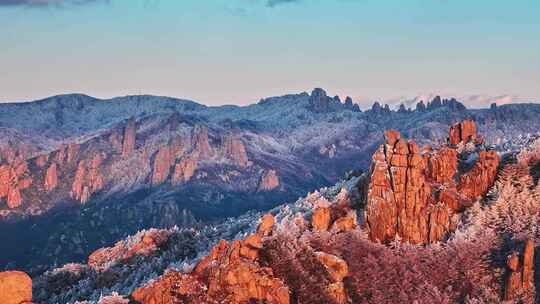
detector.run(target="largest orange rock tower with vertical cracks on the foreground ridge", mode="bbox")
[365,123,500,244]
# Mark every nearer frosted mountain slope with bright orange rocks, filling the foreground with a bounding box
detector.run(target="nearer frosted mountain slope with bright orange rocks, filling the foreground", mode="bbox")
[3,120,540,304]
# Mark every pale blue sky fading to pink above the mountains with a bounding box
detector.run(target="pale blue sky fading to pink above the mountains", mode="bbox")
[0,0,540,105]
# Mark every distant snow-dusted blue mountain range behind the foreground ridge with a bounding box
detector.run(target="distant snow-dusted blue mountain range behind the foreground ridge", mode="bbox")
[0,89,540,274]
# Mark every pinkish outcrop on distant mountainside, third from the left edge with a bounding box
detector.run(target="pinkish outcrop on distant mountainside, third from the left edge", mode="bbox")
[71,153,105,204]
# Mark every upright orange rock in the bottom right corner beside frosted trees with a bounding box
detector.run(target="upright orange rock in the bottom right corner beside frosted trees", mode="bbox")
[504,240,535,301]
